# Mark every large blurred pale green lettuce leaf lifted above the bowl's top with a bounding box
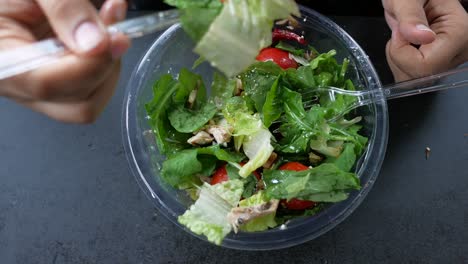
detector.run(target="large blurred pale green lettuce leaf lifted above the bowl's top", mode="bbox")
[195,0,300,76]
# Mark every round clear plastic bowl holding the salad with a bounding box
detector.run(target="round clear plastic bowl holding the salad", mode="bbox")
[123,7,388,250]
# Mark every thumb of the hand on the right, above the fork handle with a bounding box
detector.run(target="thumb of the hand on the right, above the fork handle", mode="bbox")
[389,0,435,45]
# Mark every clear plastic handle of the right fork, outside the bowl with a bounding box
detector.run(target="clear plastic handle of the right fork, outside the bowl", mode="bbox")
[382,66,468,99]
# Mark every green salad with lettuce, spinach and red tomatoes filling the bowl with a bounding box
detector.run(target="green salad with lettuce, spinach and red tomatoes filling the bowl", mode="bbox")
[146,0,367,244]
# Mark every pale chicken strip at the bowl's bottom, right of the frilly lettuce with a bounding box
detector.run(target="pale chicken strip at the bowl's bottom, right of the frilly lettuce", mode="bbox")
[227,200,279,233]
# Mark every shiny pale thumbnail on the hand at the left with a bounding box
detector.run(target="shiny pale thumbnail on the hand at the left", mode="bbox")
[75,22,104,52]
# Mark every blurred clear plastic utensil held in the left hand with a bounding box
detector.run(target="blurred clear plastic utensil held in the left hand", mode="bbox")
[0,9,179,80]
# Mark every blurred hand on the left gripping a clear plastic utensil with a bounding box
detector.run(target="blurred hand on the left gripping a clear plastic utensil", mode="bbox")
[0,0,129,123]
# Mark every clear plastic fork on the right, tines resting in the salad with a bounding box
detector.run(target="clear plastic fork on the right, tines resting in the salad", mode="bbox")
[302,66,468,122]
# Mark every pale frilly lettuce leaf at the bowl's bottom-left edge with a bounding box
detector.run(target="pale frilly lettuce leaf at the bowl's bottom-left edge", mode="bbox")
[178,180,243,245]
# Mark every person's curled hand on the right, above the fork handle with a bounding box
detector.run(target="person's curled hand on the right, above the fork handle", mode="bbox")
[382,0,468,81]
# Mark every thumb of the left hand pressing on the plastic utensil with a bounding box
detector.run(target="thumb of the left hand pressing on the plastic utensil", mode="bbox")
[37,0,109,55]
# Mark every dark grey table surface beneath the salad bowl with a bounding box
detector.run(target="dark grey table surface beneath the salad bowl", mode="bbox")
[0,13,468,264]
